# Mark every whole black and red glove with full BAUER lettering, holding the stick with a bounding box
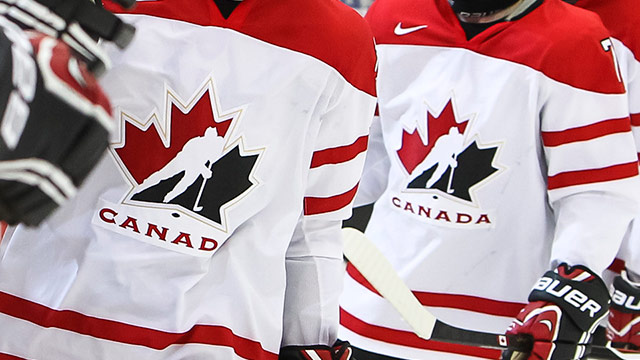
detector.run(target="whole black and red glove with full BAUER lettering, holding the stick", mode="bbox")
[502,264,609,360]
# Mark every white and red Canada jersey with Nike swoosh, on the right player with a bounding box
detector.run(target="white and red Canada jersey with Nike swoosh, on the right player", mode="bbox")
[339,0,638,360]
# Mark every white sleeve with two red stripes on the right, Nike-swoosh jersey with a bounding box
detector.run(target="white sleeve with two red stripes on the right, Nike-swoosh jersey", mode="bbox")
[541,34,640,273]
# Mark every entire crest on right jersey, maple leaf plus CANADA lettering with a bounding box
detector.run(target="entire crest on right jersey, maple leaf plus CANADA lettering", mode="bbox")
[392,96,501,227]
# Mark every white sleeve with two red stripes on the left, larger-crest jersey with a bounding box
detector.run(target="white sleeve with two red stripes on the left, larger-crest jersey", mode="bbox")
[282,23,376,346]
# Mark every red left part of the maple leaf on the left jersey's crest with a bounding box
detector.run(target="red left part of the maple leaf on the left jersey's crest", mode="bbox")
[115,90,233,184]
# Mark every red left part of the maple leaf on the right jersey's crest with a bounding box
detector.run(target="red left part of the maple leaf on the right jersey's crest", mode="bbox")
[397,100,469,174]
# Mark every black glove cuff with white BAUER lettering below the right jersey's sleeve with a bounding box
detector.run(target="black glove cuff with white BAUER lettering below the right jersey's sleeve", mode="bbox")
[529,263,610,332]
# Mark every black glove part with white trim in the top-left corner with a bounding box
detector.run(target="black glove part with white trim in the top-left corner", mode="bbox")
[0,0,135,76]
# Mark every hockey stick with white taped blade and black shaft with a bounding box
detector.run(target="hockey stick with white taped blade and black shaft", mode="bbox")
[342,228,640,360]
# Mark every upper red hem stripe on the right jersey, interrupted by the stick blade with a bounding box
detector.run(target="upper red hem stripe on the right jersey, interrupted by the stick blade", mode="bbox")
[347,263,526,317]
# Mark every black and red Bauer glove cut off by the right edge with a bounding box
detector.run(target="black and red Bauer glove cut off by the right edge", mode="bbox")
[607,271,640,350]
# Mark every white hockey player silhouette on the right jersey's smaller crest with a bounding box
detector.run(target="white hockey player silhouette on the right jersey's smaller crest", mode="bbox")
[409,126,464,188]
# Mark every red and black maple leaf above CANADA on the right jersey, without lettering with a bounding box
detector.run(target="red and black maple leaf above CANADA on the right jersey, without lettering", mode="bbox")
[397,100,498,201]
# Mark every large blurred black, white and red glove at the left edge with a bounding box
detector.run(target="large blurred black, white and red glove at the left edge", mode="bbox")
[0,21,113,225]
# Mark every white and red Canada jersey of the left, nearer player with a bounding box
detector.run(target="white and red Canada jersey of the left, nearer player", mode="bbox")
[0,0,376,360]
